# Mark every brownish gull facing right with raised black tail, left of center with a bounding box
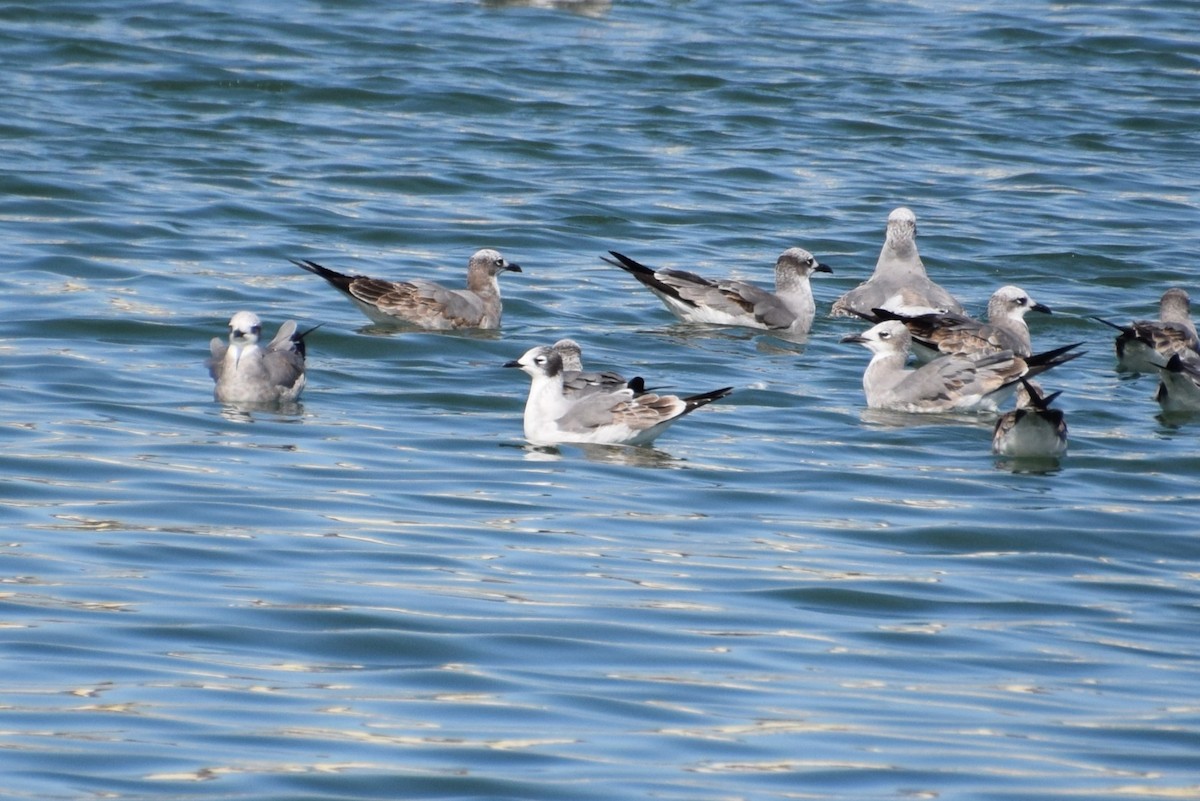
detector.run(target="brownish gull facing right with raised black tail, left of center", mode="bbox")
[289,248,521,331]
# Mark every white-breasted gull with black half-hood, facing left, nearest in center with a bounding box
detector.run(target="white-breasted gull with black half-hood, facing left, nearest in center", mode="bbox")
[504,345,733,445]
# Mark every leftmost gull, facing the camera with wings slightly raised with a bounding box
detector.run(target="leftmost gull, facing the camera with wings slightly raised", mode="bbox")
[208,312,319,403]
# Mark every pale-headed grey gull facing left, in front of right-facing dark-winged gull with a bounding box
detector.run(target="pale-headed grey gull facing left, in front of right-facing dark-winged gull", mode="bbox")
[842,320,1079,414]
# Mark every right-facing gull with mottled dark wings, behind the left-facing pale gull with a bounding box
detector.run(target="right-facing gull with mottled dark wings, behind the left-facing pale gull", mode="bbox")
[860,285,1050,361]
